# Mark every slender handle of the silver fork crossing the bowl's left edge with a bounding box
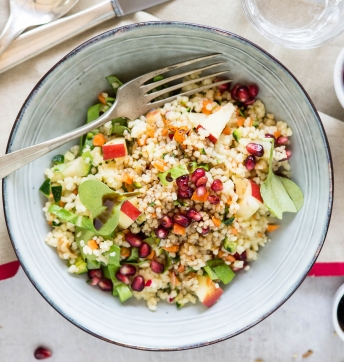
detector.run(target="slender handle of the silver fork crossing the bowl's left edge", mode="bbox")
[0,109,116,179]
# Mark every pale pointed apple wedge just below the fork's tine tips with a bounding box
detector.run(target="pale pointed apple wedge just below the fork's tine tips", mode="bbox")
[197,103,235,143]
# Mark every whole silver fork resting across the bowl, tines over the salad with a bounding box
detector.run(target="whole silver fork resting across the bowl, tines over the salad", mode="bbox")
[0,54,231,179]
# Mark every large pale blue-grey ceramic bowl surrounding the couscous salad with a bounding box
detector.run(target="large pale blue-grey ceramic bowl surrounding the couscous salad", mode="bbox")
[3,22,333,350]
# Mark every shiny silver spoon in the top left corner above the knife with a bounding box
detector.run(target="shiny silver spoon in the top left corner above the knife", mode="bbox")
[0,0,78,56]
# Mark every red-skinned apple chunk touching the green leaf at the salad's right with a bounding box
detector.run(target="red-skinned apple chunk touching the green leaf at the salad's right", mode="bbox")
[236,180,263,220]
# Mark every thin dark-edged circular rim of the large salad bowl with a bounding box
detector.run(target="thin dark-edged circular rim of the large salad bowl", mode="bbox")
[2,21,334,352]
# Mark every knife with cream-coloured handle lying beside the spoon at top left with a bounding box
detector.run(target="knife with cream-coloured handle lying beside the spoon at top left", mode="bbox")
[0,0,169,73]
